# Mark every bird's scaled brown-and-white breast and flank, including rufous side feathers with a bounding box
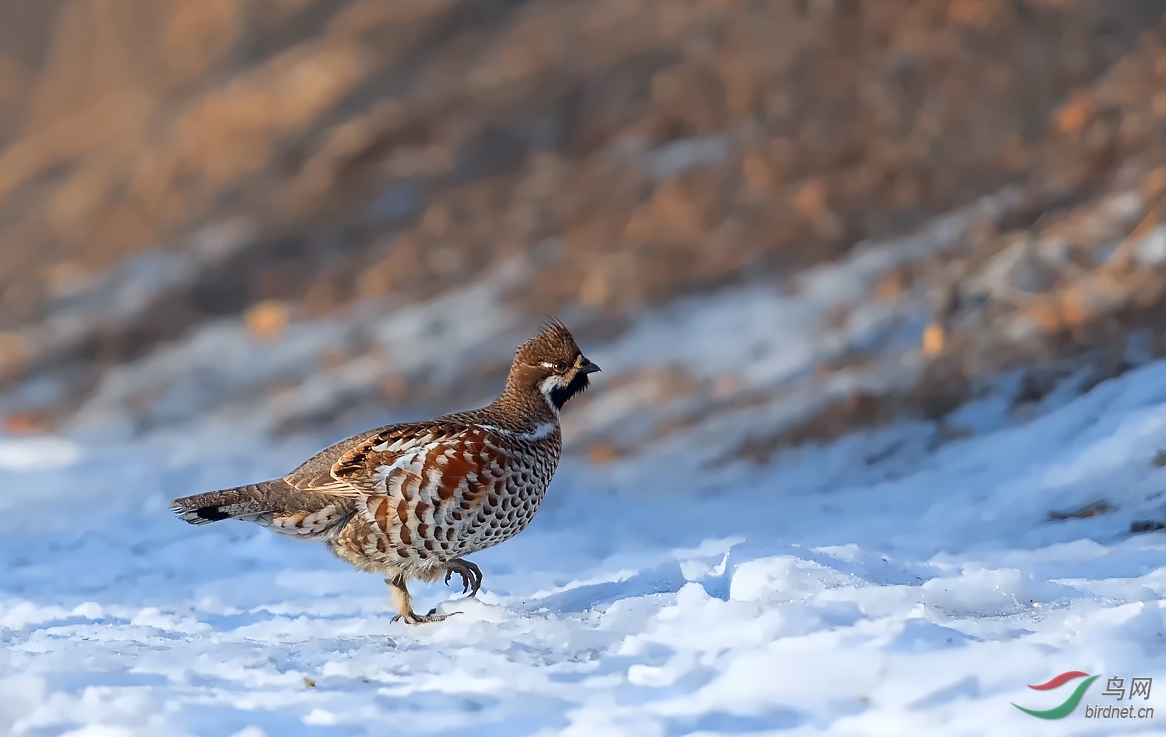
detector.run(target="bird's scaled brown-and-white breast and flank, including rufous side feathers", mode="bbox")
[332,416,562,574]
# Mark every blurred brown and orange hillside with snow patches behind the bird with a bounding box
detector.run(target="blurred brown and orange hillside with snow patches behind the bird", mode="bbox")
[0,0,1166,462]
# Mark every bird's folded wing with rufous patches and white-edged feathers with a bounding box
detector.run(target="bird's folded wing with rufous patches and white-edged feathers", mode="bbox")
[331,422,511,559]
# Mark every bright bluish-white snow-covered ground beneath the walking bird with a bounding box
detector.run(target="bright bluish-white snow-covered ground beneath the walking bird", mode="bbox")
[0,249,1166,737]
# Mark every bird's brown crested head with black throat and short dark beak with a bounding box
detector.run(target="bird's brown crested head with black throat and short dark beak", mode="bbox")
[511,321,599,412]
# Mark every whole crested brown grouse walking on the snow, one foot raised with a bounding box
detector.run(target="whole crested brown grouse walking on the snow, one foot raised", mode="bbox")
[171,323,599,624]
